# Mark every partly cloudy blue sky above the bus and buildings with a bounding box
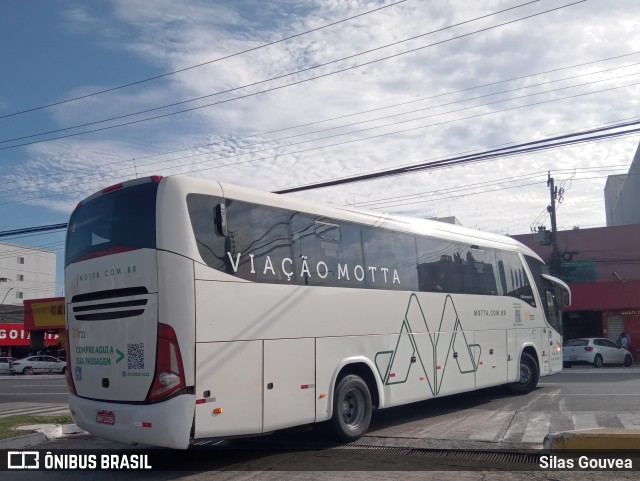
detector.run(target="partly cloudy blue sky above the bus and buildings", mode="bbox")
[0,0,640,295]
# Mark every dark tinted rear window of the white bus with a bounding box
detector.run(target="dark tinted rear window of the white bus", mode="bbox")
[65,182,158,266]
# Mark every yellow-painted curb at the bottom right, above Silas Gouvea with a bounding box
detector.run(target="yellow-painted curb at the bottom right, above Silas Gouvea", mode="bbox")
[543,428,640,451]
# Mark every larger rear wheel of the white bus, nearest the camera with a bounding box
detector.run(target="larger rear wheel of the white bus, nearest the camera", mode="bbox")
[331,374,373,442]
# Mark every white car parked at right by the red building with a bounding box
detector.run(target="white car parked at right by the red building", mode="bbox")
[562,337,633,367]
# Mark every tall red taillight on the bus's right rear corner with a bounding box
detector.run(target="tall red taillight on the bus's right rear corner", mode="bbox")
[147,324,186,401]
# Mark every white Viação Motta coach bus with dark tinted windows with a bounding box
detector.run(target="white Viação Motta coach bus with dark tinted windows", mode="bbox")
[65,176,569,448]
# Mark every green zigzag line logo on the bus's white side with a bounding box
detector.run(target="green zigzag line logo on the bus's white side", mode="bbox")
[375,294,481,396]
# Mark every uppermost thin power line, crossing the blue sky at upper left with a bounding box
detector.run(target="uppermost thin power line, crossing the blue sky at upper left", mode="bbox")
[0,0,407,119]
